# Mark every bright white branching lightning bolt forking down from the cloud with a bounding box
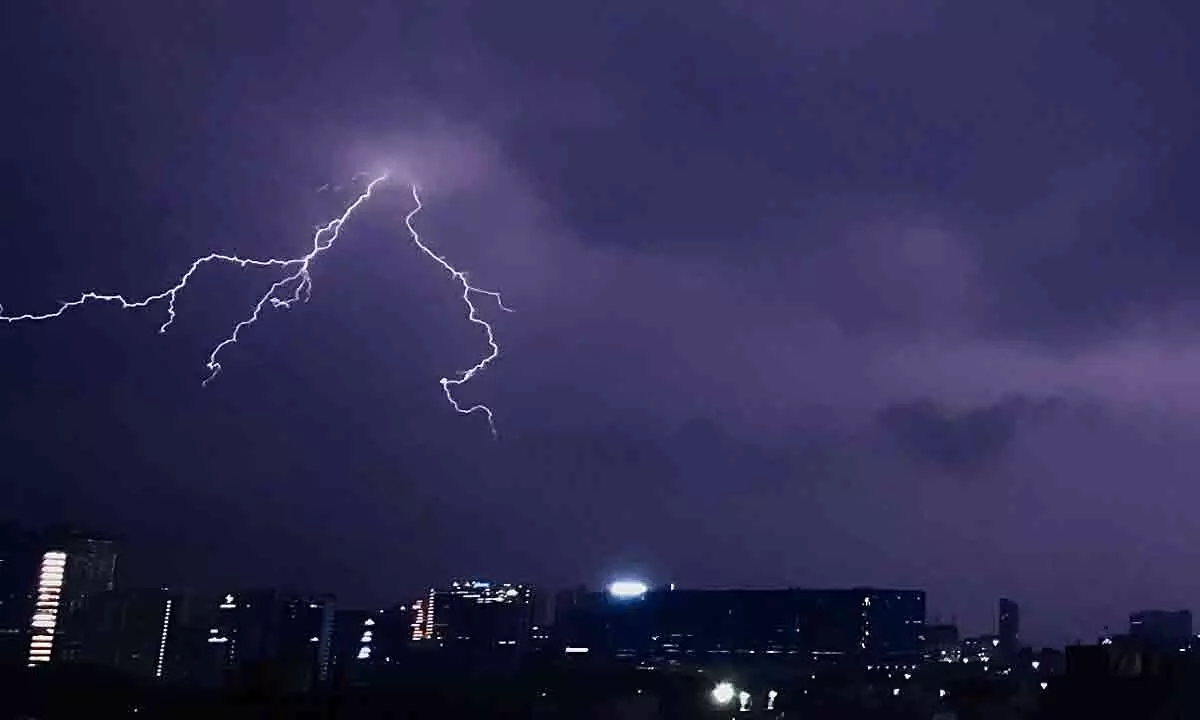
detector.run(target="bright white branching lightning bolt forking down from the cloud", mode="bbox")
[0,173,511,436]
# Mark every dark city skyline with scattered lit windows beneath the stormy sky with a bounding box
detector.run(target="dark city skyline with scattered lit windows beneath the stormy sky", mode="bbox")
[9,511,1200,718]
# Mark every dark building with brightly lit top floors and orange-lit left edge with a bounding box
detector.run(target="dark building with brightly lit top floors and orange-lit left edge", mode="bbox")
[412,580,536,648]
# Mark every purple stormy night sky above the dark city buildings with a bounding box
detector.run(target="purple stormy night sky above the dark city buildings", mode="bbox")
[0,0,1200,643]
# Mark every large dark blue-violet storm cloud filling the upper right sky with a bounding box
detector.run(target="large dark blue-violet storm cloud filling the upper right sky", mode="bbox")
[451,2,1200,343]
